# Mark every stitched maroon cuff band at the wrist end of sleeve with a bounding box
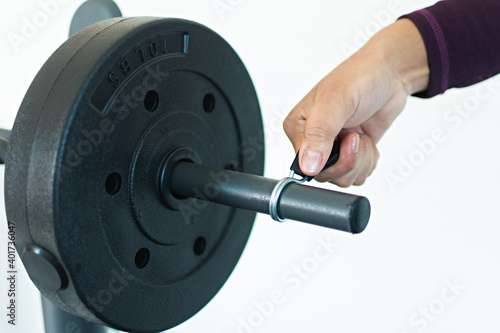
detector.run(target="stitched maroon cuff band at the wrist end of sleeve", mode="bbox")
[399,9,450,98]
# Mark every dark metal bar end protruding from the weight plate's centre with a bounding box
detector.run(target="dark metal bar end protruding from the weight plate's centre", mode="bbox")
[169,161,370,234]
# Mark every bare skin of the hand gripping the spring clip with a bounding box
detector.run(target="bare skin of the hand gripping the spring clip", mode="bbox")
[283,19,429,187]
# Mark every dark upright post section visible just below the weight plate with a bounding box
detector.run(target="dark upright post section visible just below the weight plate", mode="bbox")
[42,296,108,333]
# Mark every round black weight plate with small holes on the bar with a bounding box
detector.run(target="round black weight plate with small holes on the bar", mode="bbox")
[5,18,264,332]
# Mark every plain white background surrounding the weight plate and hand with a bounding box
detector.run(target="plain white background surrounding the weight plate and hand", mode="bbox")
[0,0,500,333]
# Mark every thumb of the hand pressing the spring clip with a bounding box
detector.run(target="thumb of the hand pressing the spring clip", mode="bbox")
[299,103,347,176]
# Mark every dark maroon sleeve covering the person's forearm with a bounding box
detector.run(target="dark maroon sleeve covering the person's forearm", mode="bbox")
[401,0,500,98]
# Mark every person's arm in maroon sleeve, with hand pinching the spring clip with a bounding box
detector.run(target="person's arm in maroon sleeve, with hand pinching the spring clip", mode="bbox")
[284,0,500,187]
